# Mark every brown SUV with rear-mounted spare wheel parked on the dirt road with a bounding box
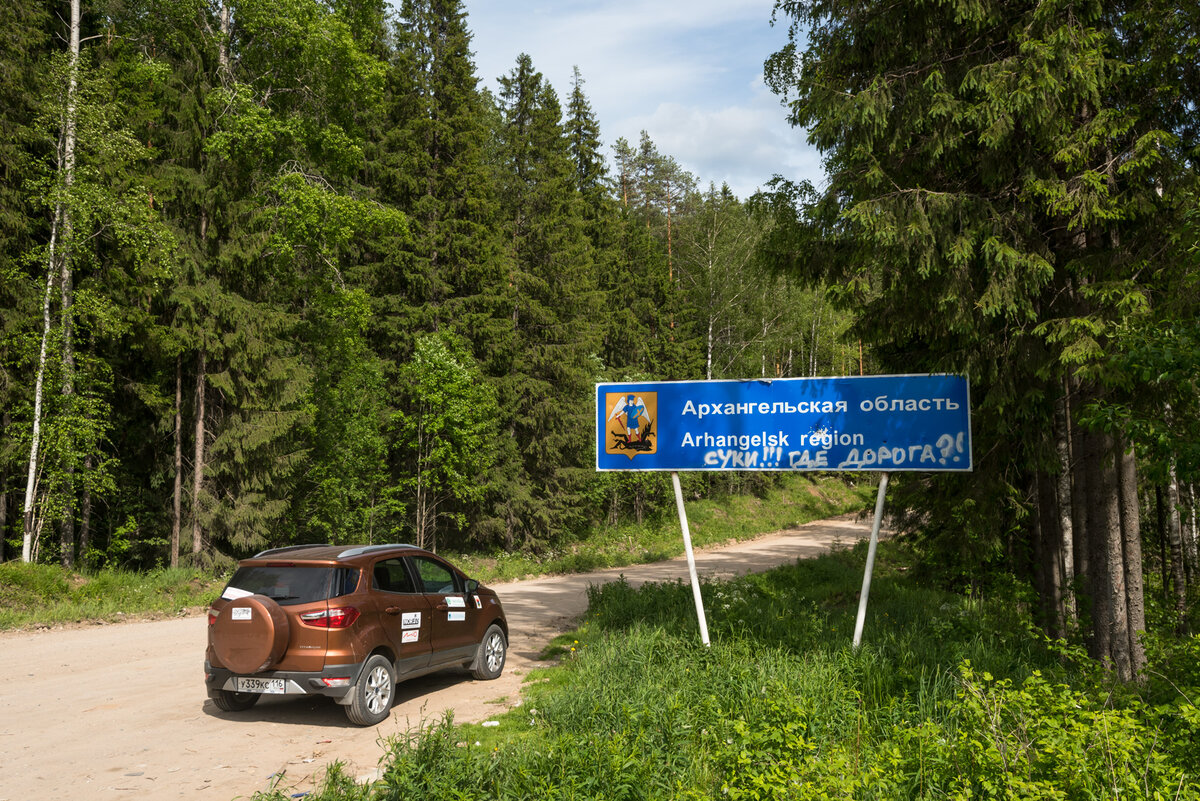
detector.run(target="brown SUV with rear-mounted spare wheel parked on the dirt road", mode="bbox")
[204,544,509,725]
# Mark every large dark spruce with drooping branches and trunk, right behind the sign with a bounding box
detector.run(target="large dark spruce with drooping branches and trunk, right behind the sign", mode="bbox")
[768,0,1195,679]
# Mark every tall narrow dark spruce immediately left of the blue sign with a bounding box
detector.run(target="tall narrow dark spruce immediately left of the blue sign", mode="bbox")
[493,54,599,544]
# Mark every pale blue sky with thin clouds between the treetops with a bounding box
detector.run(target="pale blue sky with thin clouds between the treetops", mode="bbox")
[463,0,824,198]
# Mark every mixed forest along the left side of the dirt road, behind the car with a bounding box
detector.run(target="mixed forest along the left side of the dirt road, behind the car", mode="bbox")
[0,0,857,575]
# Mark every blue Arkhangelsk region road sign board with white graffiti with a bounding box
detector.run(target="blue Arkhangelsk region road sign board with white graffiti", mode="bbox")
[596,374,973,472]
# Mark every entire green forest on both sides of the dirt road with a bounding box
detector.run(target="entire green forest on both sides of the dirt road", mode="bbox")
[0,0,1200,679]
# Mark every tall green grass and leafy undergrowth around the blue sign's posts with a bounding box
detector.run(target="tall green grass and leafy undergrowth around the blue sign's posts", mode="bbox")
[260,543,1200,801]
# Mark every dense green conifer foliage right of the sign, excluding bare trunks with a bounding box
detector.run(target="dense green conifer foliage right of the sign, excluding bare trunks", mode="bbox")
[761,0,1200,670]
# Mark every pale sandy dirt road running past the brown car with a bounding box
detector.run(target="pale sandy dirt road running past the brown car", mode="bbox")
[0,518,870,801]
